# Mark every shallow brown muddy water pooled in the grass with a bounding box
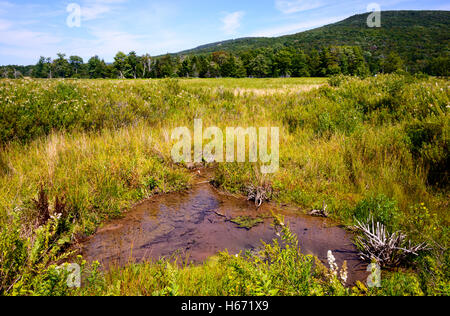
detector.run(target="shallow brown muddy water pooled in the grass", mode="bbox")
[82,179,367,284]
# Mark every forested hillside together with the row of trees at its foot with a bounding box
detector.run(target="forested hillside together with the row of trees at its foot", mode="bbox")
[0,11,450,78]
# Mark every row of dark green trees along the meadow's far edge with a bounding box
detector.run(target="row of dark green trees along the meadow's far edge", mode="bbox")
[0,46,450,79]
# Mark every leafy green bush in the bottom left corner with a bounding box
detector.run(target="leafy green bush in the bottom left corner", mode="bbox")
[0,218,70,296]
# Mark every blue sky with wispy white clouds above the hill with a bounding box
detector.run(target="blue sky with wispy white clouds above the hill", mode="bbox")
[0,0,450,65]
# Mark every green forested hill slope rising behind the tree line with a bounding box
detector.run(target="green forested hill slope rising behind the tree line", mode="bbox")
[177,11,450,61]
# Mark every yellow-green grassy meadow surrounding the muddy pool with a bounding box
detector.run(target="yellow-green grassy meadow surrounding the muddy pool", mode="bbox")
[0,74,450,295]
